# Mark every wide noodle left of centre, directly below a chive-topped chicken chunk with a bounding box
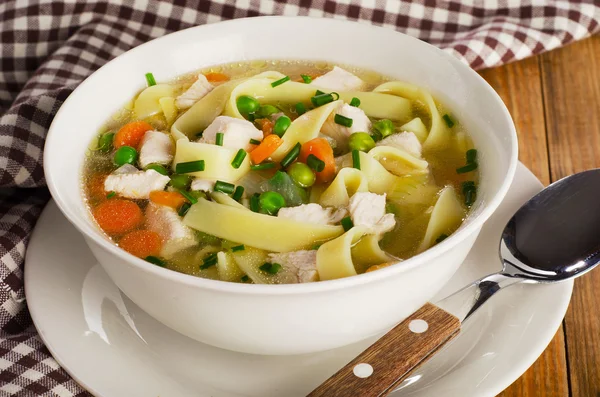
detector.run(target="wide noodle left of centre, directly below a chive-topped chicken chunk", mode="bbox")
[173,139,250,183]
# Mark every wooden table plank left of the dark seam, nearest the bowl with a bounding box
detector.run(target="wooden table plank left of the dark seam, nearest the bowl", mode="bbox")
[481,57,569,397]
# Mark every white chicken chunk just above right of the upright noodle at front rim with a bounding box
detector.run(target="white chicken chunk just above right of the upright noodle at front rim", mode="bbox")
[348,192,396,234]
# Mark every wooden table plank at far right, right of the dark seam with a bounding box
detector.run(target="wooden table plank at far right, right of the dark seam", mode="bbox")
[541,36,600,397]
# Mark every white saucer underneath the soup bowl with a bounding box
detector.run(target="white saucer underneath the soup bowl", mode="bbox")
[25,165,573,397]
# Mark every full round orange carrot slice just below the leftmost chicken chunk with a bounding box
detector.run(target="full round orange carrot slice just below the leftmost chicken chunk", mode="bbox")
[94,199,144,234]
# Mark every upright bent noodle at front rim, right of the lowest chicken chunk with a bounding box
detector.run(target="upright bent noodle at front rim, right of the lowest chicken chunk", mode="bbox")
[317,226,367,280]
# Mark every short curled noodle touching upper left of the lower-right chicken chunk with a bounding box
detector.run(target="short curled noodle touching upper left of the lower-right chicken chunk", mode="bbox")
[319,168,369,207]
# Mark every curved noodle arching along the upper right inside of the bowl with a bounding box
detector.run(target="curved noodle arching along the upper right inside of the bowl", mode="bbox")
[373,81,450,150]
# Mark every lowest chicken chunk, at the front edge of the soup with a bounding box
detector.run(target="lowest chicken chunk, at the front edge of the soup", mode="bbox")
[267,250,319,283]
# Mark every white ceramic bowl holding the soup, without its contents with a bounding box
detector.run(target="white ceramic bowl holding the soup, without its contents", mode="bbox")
[44,17,517,354]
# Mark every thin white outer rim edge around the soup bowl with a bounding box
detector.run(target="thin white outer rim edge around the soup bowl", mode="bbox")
[44,16,518,295]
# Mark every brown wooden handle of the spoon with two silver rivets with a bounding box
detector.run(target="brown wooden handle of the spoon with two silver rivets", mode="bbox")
[308,303,460,397]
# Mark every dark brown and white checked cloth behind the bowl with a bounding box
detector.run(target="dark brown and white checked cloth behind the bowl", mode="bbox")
[0,0,600,397]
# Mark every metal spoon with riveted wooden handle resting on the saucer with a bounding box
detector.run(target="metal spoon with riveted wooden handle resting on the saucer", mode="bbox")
[309,169,600,397]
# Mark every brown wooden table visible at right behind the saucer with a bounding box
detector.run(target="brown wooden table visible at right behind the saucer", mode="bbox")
[481,36,600,397]
